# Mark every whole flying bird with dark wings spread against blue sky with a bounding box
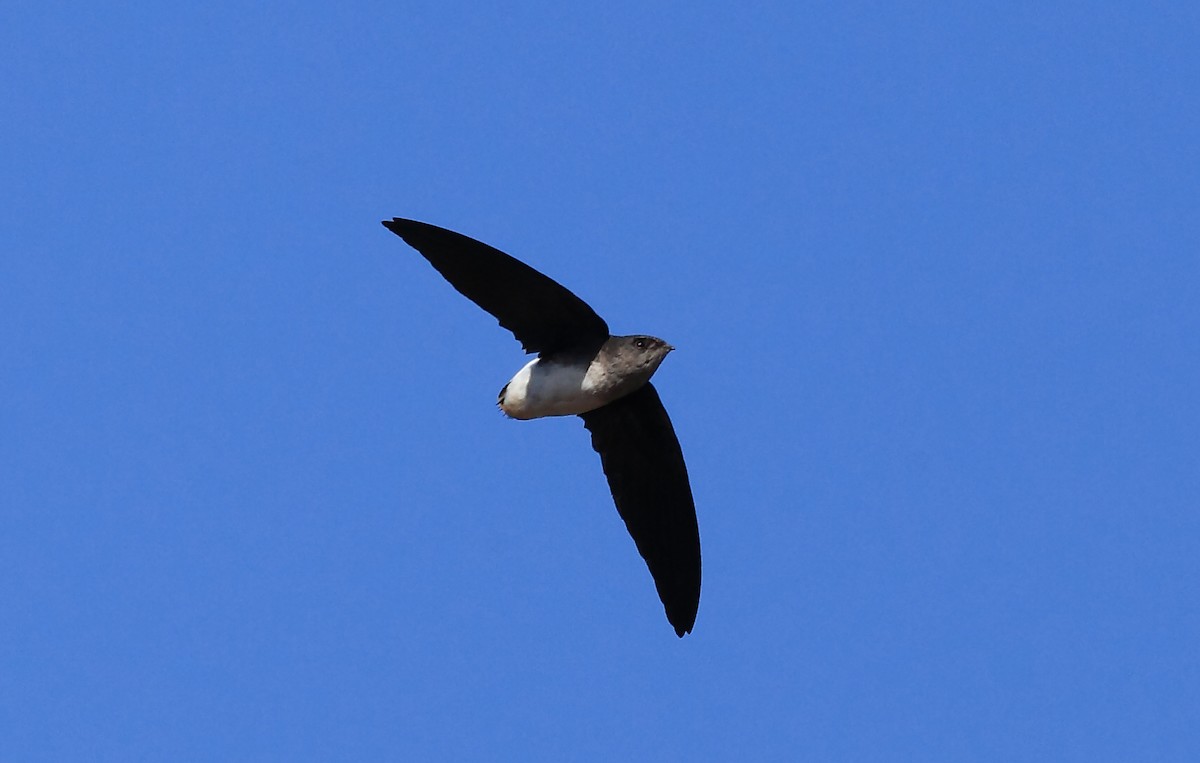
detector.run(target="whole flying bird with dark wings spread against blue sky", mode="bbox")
[382,217,701,638]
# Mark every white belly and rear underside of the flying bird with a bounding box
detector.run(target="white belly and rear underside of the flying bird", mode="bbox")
[499,358,608,419]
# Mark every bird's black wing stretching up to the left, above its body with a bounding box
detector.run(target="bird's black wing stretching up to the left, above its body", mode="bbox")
[383,217,608,354]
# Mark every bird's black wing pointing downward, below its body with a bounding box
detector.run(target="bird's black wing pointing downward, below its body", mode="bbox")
[580,384,700,638]
